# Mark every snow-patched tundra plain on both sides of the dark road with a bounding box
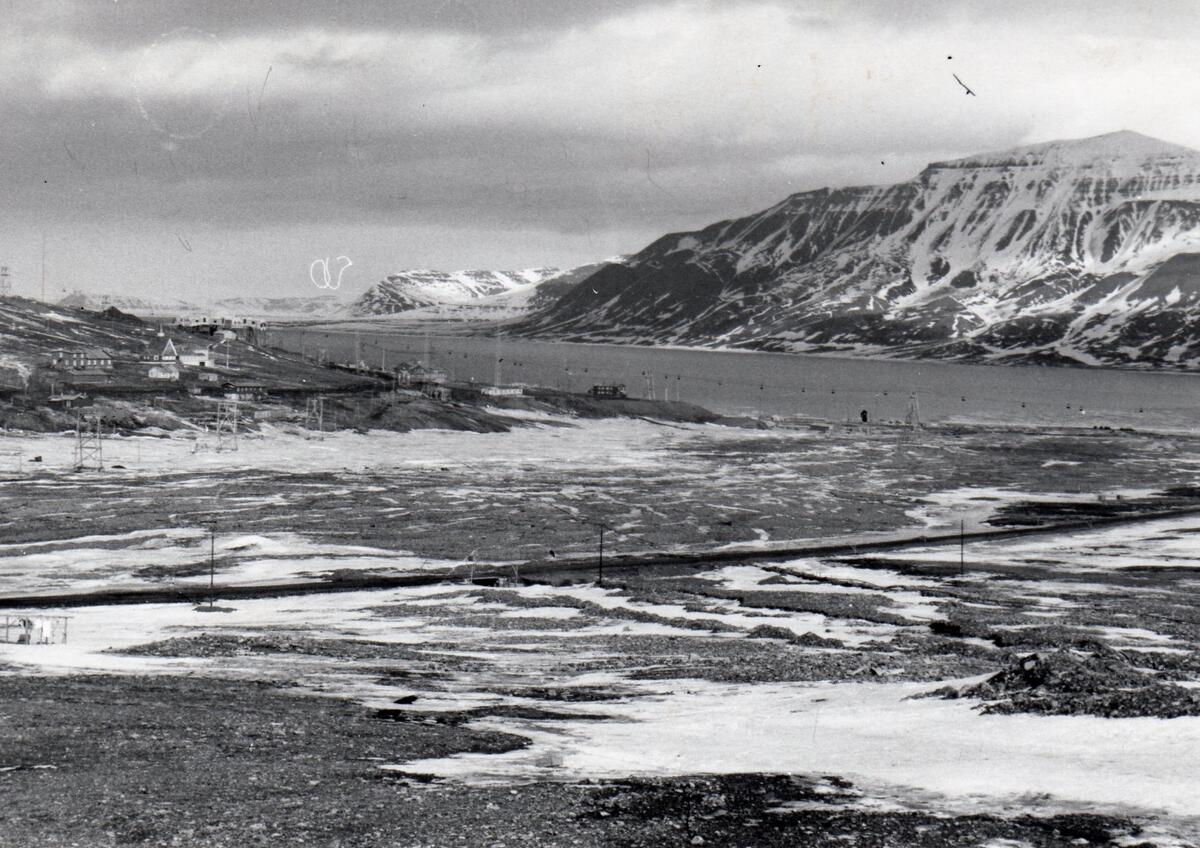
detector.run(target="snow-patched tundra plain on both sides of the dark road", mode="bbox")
[0,422,1200,848]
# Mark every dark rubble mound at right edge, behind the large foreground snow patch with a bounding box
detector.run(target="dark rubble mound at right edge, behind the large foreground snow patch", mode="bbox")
[950,650,1200,718]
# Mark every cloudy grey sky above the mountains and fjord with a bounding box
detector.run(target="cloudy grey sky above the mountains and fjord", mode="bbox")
[7,0,1200,301]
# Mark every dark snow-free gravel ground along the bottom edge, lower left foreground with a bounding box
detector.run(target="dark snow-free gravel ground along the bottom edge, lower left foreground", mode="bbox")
[0,676,1148,848]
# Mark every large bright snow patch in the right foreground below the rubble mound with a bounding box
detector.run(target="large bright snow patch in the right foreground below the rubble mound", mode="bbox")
[396,681,1200,817]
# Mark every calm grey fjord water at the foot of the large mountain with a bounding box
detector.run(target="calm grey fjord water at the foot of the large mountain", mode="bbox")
[269,325,1200,431]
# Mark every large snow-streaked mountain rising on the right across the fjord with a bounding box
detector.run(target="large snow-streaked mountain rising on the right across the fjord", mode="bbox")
[518,132,1200,365]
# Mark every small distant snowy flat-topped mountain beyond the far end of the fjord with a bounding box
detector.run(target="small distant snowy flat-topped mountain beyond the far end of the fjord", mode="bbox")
[352,265,600,320]
